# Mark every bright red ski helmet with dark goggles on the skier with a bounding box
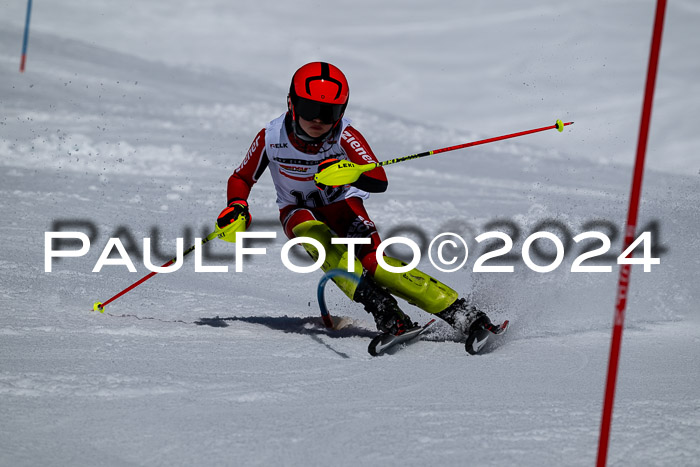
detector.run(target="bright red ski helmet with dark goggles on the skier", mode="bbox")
[289,62,350,128]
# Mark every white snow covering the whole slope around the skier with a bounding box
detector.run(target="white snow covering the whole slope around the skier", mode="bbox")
[0,0,700,466]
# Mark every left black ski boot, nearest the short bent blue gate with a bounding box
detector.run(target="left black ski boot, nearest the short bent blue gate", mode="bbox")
[353,272,417,336]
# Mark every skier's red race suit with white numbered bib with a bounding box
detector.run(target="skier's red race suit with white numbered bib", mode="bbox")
[227,114,387,273]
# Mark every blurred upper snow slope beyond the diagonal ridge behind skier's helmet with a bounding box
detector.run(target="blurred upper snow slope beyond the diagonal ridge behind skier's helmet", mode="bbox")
[0,0,700,175]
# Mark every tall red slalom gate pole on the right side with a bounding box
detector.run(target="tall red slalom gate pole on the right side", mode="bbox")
[597,0,666,467]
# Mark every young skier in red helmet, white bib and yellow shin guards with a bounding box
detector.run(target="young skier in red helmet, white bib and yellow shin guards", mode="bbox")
[217,62,493,342]
